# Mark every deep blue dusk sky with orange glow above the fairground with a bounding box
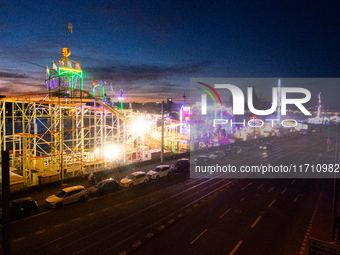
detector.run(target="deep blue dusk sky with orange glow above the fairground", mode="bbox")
[0,0,340,106]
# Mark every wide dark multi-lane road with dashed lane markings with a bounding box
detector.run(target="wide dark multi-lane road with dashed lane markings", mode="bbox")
[0,133,332,254]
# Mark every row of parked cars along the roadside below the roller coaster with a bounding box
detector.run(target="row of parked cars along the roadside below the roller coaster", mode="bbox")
[1,158,190,220]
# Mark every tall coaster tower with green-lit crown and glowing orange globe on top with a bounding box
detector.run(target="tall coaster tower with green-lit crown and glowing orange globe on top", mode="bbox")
[46,48,85,182]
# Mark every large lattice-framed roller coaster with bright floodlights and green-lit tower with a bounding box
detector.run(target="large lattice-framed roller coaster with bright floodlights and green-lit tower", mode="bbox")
[0,49,188,186]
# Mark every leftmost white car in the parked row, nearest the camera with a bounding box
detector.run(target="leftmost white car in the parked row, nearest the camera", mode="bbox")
[45,185,87,209]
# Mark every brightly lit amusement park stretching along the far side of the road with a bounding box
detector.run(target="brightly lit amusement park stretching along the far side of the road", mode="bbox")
[0,51,338,191]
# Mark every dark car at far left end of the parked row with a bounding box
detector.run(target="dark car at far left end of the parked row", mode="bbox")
[6,197,38,221]
